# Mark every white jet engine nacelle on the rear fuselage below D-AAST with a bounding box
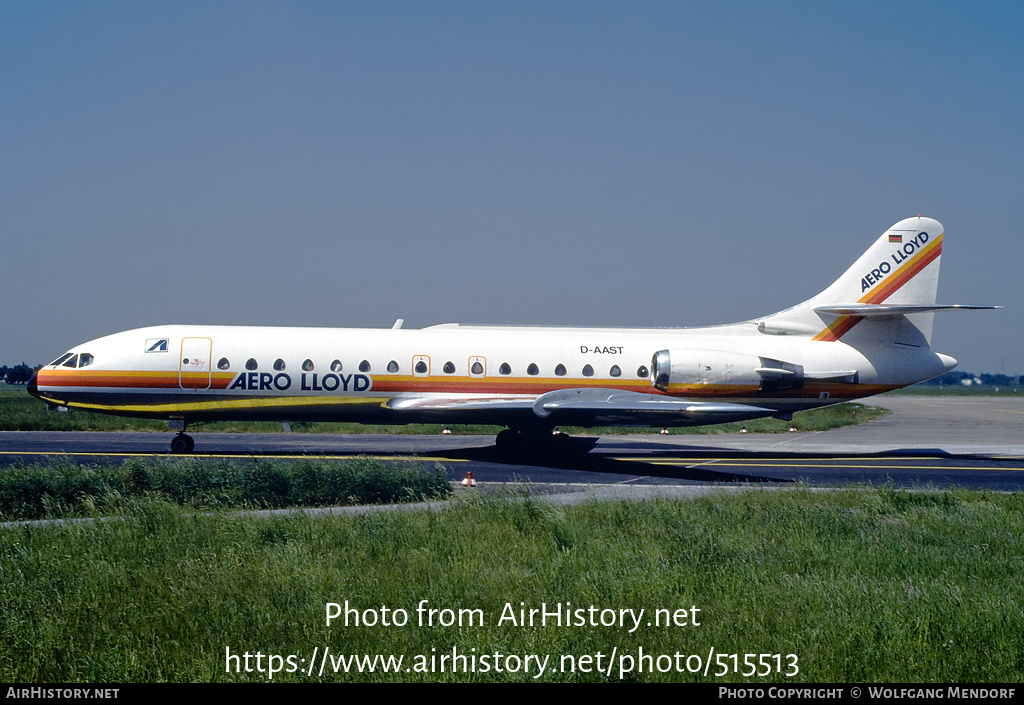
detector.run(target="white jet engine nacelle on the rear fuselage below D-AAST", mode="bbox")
[650,348,804,391]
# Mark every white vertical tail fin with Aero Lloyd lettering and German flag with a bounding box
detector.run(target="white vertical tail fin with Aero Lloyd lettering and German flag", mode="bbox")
[758,216,946,346]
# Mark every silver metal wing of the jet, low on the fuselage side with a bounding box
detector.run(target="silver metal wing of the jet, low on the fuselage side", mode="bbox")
[387,388,779,426]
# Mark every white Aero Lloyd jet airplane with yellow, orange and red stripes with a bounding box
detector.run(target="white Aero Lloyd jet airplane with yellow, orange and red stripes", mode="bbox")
[29,216,997,453]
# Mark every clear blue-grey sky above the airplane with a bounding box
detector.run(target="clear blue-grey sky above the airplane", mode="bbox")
[0,0,1024,374]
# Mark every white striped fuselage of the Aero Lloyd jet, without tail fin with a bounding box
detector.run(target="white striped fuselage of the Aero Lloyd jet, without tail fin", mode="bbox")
[29,322,945,425]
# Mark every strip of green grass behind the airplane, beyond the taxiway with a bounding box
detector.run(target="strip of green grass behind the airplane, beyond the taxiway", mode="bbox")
[0,385,889,436]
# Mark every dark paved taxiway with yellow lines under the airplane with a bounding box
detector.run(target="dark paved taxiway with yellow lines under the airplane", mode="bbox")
[0,397,1024,491]
